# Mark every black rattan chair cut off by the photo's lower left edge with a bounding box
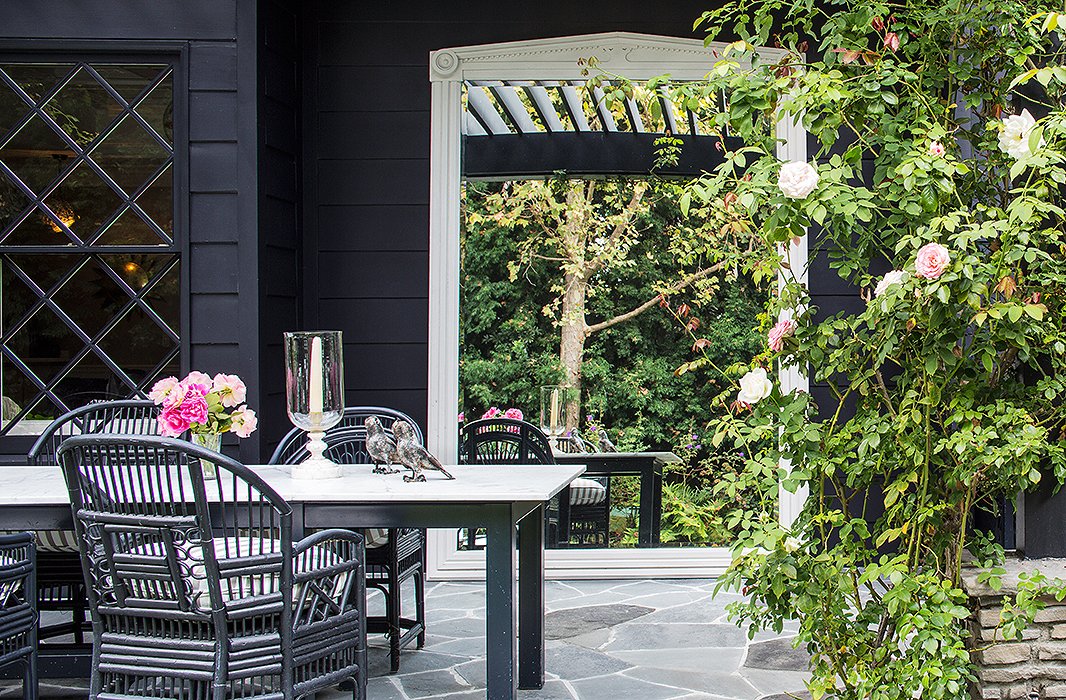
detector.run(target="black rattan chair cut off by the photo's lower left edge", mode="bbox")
[0,533,37,700]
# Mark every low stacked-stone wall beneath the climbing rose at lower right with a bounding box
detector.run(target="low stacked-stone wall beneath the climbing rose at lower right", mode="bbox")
[963,559,1066,700]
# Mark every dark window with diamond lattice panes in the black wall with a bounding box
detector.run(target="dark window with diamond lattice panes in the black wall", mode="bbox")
[0,61,181,435]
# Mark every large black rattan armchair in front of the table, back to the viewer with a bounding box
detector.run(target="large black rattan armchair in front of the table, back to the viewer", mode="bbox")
[59,435,367,700]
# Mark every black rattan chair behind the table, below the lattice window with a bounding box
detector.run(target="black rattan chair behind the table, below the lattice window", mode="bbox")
[27,398,159,645]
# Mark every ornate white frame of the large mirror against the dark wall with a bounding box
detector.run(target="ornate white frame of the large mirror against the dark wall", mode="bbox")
[426,32,808,580]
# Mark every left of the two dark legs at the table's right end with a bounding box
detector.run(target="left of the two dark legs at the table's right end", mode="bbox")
[485,504,518,700]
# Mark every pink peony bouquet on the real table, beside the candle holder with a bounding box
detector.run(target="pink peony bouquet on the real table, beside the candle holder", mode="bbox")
[148,372,259,438]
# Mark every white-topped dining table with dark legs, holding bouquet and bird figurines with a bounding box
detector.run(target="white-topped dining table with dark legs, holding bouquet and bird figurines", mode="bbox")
[0,463,584,700]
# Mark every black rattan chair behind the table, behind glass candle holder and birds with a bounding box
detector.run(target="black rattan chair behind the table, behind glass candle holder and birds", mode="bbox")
[271,406,425,673]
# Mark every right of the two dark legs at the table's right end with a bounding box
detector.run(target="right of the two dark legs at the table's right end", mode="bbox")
[518,505,544,689]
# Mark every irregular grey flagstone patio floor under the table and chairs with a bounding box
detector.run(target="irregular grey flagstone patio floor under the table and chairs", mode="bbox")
[6,581,807,700]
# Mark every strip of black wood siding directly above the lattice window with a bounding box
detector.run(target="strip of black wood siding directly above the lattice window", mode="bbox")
[0,0,237,42]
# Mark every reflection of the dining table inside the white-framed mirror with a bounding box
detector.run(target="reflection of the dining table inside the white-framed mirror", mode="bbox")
[555,452,681,547]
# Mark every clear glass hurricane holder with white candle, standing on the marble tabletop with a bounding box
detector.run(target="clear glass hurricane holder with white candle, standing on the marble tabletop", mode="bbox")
[285,330,344,478]
